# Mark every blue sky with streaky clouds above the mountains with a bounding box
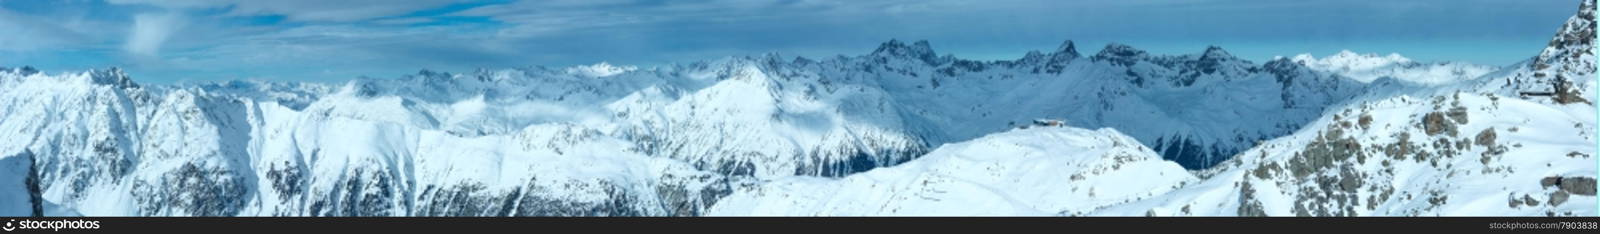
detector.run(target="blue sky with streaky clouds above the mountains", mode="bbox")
[0,0,1578,83]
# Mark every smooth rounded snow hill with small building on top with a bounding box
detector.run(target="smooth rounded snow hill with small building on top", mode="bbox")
[707,127,1195,216]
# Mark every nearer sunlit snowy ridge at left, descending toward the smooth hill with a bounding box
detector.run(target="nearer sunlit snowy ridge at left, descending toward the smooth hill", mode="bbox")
[0,69,730,216]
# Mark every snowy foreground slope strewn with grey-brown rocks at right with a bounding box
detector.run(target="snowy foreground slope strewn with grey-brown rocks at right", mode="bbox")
[1094,93,1597,216]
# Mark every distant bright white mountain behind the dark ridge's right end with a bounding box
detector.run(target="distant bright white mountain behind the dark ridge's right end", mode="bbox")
[1290,50,1499,85]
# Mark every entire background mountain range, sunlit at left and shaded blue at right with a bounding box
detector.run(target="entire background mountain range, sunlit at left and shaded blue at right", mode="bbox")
[0,40,1362,215]
